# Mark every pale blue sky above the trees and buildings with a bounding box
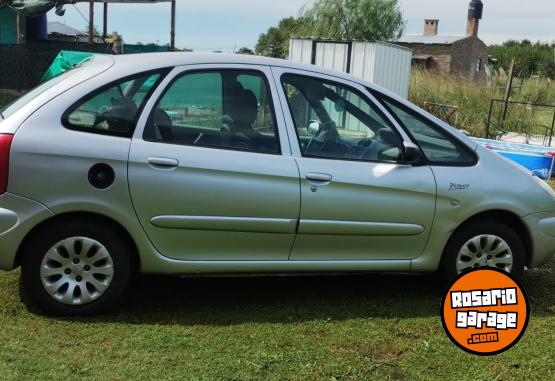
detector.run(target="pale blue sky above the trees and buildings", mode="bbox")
[48,0,555,51]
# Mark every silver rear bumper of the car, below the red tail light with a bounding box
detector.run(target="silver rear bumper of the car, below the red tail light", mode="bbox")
[0,193,54,271]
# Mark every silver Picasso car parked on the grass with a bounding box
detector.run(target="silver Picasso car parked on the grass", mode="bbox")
[0,53,555,315]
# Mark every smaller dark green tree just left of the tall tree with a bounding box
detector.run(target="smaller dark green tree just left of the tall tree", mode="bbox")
[255,17,306,58]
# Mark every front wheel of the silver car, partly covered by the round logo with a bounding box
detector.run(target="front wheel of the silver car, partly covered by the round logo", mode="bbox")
[440,220,525,280]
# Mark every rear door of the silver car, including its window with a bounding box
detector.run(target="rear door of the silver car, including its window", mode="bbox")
[129,65,300,260]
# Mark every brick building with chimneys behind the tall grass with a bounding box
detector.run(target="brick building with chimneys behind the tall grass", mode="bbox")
[397,0,488,80]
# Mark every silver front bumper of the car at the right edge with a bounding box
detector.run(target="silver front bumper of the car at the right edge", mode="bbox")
[523,212,555,268]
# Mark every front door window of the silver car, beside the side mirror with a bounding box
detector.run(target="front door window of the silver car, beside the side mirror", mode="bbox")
[282,74,402,162]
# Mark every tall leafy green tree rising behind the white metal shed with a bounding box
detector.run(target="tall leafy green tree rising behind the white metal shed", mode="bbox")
[301,0,405,41]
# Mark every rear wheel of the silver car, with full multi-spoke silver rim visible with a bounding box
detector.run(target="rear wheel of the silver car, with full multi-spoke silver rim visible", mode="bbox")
[20,221,133,316]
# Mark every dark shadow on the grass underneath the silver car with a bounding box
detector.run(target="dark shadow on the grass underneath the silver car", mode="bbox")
[80,261,555,325]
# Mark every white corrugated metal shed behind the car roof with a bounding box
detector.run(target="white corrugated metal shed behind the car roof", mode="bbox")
[289,38,412,98]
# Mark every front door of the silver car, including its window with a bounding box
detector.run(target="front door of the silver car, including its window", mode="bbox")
[273,68,436,262]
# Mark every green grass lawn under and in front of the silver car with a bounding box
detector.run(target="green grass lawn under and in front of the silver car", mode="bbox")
[0,223,555,380]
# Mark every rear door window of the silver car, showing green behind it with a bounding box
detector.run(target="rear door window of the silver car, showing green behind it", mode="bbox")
[144,70,280,154]
